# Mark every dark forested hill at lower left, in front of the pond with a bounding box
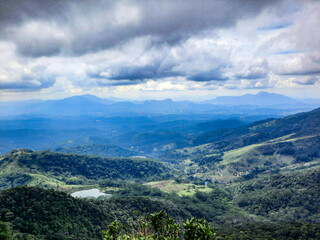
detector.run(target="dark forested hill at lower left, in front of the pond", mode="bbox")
[0,186,190,240]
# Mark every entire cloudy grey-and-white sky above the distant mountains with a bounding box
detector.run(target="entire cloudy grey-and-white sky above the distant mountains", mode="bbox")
[0,0,320,101]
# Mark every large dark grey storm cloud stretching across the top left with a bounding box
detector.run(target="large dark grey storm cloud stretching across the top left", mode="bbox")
[0,0,279,57]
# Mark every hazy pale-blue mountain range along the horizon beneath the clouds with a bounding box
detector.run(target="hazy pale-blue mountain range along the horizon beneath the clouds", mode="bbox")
[0,92,318,119]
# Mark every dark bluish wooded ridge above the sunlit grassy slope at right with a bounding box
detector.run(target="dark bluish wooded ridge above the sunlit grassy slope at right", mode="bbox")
[193,108,320,149]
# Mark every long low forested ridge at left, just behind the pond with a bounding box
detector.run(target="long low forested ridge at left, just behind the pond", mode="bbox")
[0,149,172,189]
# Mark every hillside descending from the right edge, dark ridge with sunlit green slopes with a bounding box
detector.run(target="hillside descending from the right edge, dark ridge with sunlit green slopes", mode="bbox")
[165,109,320,183]
